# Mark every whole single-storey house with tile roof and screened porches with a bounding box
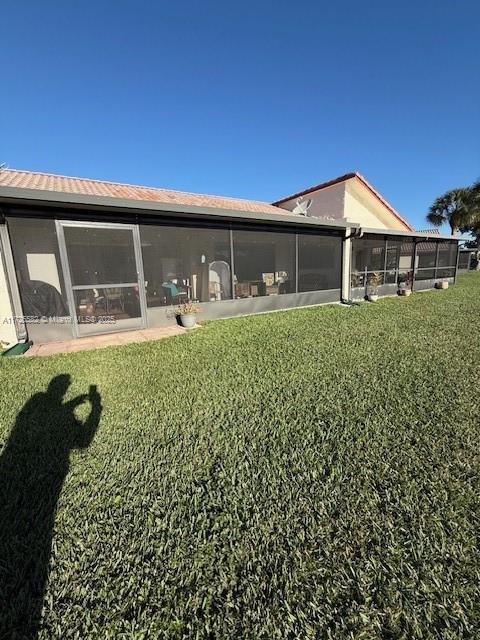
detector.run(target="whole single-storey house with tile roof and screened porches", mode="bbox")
[0,169,458,342]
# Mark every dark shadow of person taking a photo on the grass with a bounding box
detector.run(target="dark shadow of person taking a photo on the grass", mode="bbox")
[0,374,102,640]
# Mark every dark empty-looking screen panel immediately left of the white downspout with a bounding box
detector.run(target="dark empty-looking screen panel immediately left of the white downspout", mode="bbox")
[298,233,342,292]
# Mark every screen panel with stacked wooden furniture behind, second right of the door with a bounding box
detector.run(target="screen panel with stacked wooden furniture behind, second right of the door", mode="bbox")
[233,229,295,298]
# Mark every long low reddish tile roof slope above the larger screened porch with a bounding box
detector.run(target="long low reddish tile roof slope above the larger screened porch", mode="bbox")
[0,169,292,215]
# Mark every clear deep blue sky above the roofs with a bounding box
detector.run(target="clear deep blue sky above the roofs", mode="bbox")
[0,0,480,228]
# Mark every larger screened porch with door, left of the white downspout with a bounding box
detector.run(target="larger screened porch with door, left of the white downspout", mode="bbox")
[0,208,345,342]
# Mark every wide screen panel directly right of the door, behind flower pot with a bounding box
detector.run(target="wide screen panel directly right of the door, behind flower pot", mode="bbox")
[140,225,231,307]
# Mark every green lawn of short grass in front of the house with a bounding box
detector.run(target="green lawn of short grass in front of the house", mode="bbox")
[0,273,480,640]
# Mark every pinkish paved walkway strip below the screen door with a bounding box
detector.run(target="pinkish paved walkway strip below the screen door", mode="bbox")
[25,326,186,356]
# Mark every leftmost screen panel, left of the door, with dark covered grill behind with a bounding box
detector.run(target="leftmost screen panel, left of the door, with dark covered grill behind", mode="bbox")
[8,218,69,317]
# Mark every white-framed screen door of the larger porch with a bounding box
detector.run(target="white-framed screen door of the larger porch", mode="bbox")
[59,221,145,336]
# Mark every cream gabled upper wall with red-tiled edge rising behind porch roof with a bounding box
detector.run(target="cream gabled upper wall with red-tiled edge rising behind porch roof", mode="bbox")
[273,172,414,231]
